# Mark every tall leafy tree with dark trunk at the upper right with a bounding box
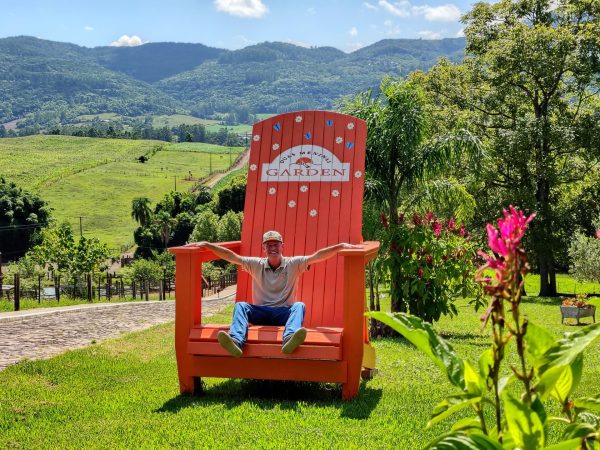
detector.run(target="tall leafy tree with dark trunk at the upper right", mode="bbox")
[417,0,600,296]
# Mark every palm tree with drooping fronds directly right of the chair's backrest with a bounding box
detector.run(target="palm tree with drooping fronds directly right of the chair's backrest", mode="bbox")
[342,77,482,312]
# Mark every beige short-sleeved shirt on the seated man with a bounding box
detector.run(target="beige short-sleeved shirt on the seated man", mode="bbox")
[242,256,308,306]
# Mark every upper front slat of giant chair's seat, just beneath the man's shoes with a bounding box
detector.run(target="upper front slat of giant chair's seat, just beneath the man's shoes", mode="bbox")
[187,341,342,360]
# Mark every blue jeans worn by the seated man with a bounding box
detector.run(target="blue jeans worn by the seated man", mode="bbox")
[229,302,306,348]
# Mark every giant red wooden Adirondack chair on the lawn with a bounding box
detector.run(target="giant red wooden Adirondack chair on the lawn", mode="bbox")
[170,111,379,399]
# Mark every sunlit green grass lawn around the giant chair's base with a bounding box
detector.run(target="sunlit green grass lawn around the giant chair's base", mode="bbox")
[0,299,600,449]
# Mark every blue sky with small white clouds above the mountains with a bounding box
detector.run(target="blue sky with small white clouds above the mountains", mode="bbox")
[0,0,474,52]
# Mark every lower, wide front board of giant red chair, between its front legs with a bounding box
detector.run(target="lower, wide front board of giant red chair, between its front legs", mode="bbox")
[190,356,347,383]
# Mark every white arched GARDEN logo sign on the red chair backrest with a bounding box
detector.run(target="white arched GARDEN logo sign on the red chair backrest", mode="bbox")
[260,145,350,182]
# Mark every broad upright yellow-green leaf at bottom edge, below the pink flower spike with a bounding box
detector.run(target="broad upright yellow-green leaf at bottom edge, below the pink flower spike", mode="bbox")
[503,393,545,450]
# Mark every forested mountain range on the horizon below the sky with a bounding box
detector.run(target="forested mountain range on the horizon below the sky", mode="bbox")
[0,36,465,124]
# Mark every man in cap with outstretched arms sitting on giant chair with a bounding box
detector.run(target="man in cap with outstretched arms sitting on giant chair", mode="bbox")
[188,231,361,358]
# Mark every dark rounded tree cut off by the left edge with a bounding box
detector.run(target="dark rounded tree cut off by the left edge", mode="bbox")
[0,177,50,260]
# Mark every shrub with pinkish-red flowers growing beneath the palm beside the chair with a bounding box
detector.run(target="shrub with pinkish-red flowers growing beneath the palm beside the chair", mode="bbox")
[381,213,481,322]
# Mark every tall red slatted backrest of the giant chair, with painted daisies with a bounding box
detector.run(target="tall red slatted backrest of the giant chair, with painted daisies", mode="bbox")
[237,111,367,326]
